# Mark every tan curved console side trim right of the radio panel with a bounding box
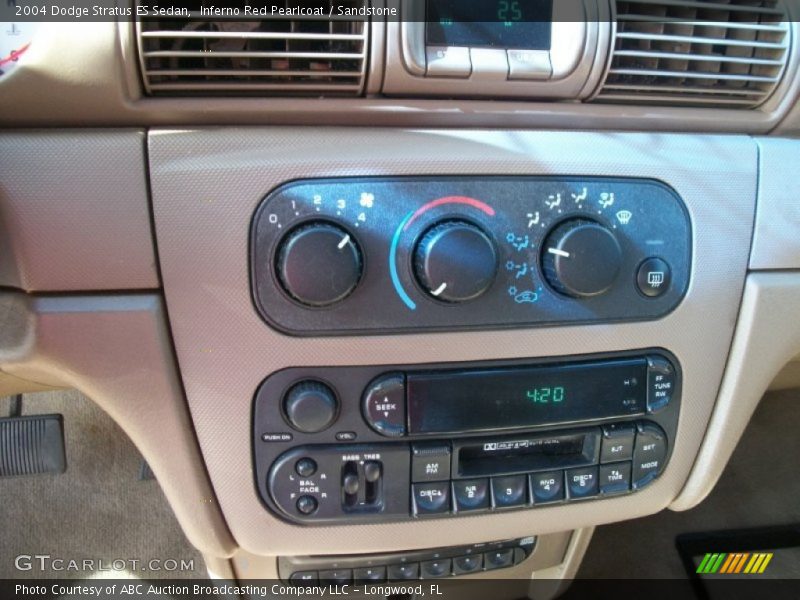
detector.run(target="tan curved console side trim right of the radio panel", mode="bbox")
[670,272,800,510]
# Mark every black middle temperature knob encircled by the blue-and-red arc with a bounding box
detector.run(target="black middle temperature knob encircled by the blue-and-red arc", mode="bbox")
[414,220,497,302]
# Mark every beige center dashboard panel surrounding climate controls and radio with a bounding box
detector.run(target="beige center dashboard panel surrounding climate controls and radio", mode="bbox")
[149,128,757,555]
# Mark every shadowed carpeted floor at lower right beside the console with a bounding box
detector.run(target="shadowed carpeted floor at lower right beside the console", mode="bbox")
[578,390,800,579]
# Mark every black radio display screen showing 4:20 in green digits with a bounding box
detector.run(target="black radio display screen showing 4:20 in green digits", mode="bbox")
[406,358,647,434]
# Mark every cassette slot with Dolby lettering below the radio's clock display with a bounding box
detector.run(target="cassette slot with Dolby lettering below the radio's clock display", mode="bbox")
[453,428,600,477]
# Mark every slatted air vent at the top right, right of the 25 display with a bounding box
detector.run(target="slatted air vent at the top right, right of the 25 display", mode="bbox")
[597,0,790,108]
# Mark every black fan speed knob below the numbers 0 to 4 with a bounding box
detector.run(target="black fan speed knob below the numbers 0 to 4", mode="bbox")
[275,221,362,307]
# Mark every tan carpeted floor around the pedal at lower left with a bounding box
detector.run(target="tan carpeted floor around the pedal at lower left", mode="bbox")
[0,391,207,579]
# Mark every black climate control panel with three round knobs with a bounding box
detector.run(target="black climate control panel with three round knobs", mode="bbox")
[251,177,691,335]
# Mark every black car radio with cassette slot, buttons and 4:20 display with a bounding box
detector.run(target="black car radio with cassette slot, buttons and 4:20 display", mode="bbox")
[253,350,681,524]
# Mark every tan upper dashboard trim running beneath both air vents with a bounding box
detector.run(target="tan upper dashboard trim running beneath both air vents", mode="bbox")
[0,22,800,134]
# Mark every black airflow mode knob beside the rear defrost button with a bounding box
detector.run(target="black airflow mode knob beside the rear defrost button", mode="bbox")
[542,219,622,298]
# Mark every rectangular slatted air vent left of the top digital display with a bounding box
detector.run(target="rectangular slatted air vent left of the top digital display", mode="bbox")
[137,0,369,96]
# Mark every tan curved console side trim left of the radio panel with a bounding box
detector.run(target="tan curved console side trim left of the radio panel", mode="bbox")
[0,292,235,557]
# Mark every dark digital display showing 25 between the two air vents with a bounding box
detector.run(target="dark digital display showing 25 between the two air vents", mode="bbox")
[425,0,553,50]
